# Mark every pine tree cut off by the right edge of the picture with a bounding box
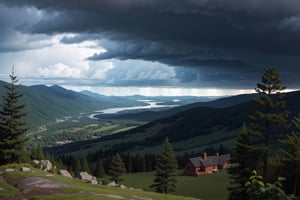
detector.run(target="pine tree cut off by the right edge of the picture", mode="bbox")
[277,114,300,195]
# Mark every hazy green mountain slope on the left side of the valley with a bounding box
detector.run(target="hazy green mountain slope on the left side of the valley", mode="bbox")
[0,81,142,127]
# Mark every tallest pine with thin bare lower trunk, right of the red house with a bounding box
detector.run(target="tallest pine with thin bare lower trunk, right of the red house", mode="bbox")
[249,67,289,183]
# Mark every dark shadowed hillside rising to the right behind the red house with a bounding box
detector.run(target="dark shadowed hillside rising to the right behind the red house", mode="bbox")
[48,91,300,155]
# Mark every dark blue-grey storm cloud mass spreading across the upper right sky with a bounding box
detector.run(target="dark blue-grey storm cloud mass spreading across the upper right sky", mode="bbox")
[0,0,300,86]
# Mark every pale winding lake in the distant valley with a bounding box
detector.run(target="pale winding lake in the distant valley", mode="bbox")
[90,100,178,118]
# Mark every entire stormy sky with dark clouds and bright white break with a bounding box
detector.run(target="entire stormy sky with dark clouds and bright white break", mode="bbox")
[0,0,300,95]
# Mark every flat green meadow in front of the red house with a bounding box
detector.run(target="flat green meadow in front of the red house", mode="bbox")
[123,171,229,200]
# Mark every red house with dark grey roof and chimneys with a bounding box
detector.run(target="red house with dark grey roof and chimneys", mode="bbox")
[185,153,230,176]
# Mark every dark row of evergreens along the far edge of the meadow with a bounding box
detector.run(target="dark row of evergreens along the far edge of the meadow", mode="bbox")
[54,145,230,177]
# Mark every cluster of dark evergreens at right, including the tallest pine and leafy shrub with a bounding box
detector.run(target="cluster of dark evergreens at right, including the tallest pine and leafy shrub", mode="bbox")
[228,67,300,200]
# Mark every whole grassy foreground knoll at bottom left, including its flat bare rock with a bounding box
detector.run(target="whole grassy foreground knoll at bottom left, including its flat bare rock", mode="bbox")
[0,164,197,200]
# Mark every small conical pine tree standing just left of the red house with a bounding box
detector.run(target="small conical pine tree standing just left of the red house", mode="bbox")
[150,138,178,193]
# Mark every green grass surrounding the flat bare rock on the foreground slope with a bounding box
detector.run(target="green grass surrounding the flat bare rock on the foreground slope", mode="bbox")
[0,164,199,200]
